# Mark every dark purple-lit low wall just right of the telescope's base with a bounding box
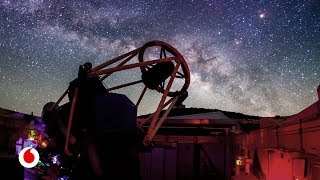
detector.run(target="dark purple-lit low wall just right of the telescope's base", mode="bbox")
[140,143,232,180]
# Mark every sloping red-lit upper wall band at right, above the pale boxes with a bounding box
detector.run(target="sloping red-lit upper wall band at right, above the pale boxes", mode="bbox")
[244,117,320,155]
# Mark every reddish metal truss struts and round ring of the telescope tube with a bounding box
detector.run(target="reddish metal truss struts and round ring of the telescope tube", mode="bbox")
[53,41,190,154]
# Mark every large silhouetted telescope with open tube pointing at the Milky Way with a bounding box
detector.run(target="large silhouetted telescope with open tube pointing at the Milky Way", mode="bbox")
[44,41,190,155]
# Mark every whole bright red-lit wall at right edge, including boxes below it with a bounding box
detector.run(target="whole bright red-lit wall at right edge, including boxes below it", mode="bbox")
[233,95,320,180]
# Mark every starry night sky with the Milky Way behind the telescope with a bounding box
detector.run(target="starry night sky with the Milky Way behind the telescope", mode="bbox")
[0,0,320,116]
